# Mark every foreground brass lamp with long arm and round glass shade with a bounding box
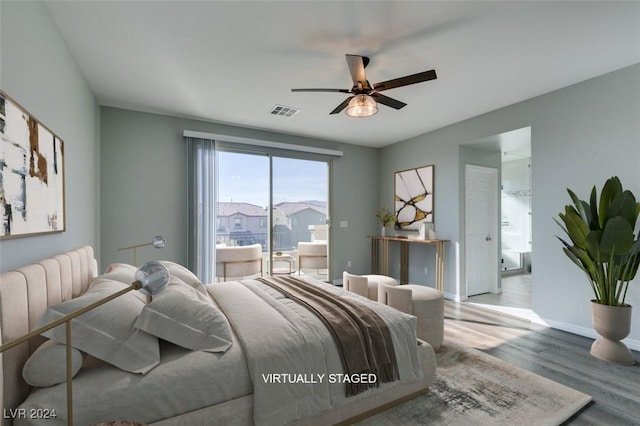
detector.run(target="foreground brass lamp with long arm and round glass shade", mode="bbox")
[0,262,169,425]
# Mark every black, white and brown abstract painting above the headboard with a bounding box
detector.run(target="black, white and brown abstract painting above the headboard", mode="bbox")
[0,91,65,239]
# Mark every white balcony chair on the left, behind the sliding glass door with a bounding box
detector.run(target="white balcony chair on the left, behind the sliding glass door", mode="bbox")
[216,244,263,281]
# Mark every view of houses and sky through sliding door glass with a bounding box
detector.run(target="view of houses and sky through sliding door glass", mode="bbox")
[216,151,328,252]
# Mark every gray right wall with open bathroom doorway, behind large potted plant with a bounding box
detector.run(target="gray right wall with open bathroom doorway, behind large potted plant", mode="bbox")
[380,65,640,349]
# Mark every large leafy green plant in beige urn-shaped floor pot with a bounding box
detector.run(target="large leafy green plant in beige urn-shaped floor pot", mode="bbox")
[556,176,640,365]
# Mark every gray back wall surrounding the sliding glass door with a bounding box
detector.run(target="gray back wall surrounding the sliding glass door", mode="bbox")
[100,107,378,278]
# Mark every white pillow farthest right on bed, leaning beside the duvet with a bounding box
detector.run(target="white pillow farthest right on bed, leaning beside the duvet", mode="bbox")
[134,276,232,352]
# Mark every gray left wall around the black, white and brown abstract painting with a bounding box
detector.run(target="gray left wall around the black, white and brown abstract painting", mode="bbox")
[0,1,100,271]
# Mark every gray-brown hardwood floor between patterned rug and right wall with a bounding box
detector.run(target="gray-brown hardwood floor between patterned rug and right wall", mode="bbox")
[445,300,640,426]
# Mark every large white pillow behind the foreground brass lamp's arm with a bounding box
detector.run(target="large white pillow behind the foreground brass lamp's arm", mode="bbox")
[35,276,160,374]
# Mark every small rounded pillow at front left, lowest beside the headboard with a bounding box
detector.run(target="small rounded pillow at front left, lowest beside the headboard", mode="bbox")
[22,340,84,388]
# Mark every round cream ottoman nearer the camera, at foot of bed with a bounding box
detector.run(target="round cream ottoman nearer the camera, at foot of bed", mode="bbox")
[378,284,444,350]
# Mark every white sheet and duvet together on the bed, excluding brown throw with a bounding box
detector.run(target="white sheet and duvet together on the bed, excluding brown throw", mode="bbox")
[15,280,422,425]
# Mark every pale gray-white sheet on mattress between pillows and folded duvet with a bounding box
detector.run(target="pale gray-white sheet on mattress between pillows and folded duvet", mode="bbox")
[14,336,253,426]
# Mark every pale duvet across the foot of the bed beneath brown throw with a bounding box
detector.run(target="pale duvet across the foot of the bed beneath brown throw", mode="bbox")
[209,280,422,425]
